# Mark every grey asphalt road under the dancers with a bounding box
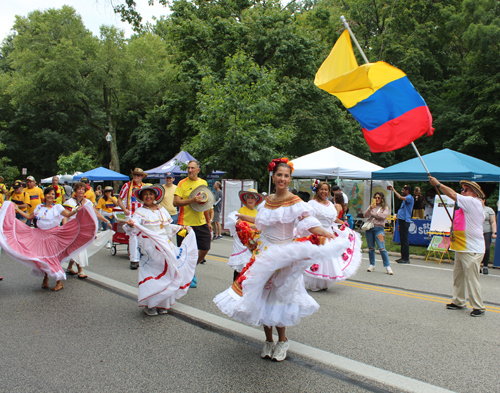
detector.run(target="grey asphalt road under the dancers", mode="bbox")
[0,233,500,392]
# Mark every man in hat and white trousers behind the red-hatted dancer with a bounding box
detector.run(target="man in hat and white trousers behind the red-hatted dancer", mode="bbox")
[118,168,148,270]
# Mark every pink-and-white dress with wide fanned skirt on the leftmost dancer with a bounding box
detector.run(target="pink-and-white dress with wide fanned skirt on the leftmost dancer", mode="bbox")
[0,202,98,280]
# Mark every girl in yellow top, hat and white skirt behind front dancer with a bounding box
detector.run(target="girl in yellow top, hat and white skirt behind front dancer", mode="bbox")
[226,188,264,281]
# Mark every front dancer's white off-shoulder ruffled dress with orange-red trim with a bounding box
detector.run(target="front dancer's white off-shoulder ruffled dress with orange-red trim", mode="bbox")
[214,195,361,327]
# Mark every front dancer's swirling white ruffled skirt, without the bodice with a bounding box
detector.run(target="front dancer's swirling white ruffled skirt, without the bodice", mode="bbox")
[214,231,350,327]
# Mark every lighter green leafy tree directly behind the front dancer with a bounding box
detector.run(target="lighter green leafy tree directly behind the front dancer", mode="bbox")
[185,52,293,179]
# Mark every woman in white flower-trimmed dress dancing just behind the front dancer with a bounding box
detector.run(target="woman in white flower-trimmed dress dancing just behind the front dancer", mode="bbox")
[299,182,361,291]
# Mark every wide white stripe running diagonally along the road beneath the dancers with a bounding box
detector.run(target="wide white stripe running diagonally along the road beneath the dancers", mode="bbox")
[85,270,452,393]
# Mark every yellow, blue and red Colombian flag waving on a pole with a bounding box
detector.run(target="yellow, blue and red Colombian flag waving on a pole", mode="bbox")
[314,30,434,153]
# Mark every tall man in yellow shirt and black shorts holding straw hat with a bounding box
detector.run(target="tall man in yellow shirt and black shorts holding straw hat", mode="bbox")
[174,160,212,281]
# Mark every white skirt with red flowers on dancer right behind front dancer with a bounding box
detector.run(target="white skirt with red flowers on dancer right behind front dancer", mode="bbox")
[304,226,361,291]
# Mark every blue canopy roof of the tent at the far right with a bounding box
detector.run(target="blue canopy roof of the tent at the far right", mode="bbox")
[372,149,500,182]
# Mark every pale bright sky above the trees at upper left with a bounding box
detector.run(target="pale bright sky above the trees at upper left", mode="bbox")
[0,0,168,42]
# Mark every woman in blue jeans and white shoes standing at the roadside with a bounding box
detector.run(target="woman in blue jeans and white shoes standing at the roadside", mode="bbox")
[363,192,394,275]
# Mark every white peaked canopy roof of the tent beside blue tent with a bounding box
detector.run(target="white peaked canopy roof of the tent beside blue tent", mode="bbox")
[292,146,384,179]
